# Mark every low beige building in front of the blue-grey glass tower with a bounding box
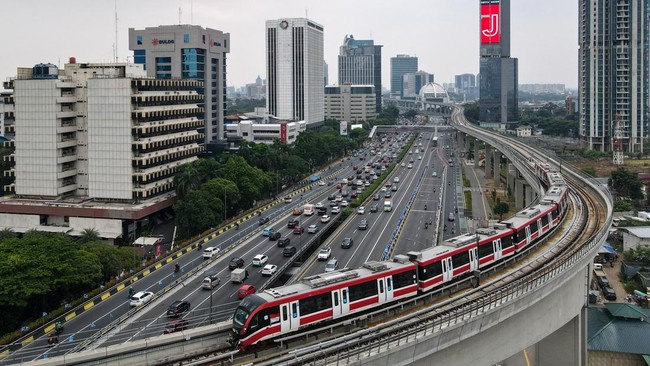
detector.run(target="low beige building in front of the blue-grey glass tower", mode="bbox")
[325,84,377,122]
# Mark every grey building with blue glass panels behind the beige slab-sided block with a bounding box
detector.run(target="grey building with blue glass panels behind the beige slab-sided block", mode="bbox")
[129,24,230,143]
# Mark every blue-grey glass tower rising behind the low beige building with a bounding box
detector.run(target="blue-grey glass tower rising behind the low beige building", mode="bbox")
[339,35,383,113]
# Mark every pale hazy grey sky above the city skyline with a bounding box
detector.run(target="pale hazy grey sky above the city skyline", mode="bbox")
[0,0,578,88]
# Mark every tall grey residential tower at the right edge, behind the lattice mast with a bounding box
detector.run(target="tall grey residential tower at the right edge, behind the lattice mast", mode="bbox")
[578,0,650,153]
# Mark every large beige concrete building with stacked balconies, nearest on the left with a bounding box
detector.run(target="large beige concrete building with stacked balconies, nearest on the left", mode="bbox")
[0,59,204,240]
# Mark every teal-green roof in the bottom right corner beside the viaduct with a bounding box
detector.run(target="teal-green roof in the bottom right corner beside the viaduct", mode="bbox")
[587,303,650,355]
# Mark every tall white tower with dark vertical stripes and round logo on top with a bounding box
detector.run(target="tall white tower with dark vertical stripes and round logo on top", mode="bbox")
[266,18,325,127]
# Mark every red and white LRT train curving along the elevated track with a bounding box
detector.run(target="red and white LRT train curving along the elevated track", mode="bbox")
[232,165,569,349]
